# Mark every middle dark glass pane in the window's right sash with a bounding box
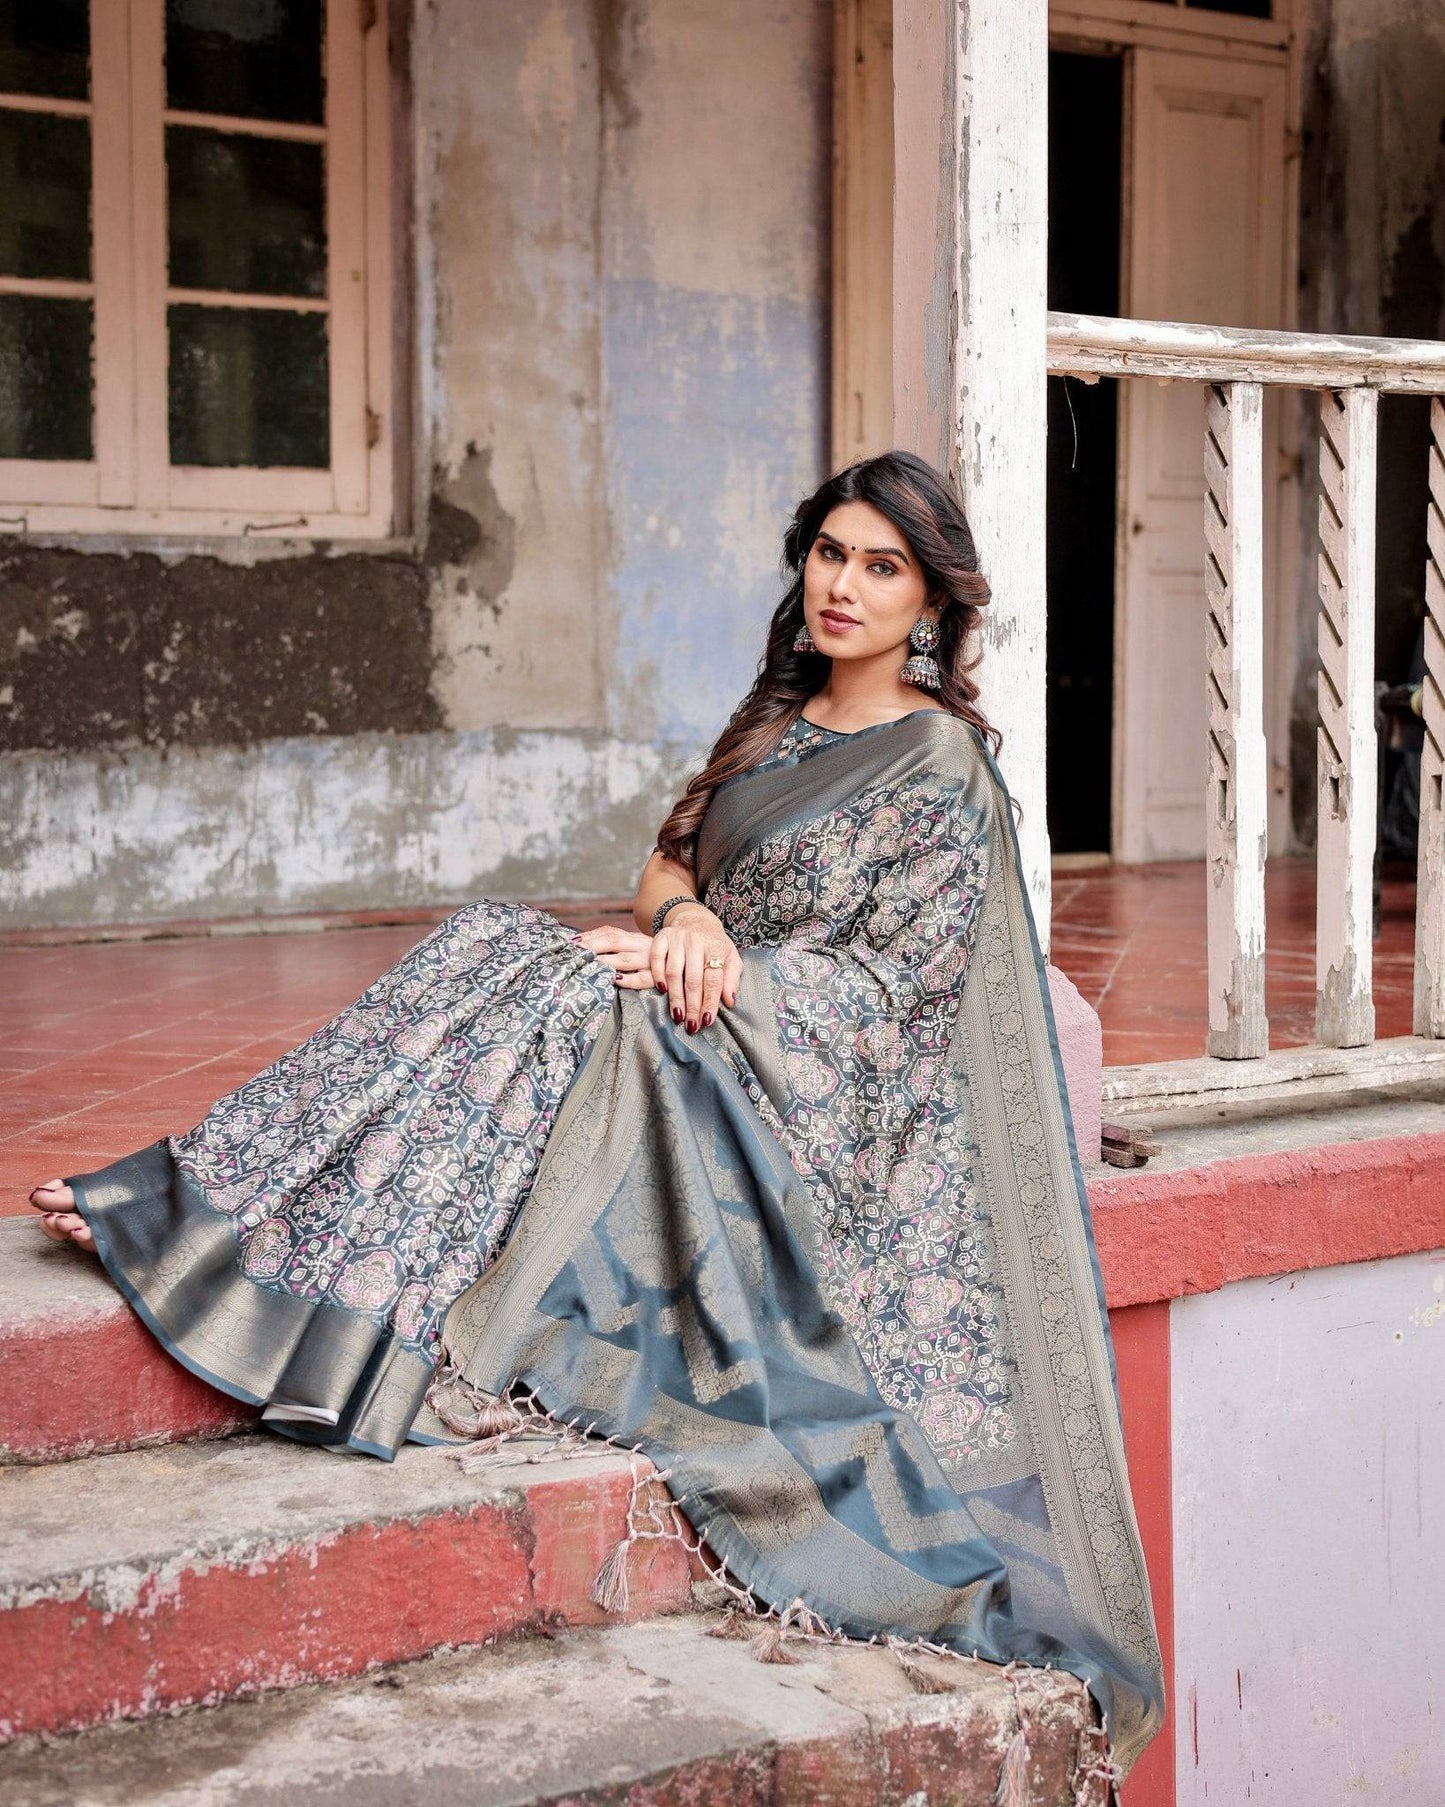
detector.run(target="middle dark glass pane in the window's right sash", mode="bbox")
[166,125,327,296]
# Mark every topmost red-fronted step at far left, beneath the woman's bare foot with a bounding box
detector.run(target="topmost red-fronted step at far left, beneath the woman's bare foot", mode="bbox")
[0,1216,256,1464]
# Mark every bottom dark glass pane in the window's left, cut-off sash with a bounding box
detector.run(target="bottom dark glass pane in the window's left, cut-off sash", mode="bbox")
[0,295,94,459]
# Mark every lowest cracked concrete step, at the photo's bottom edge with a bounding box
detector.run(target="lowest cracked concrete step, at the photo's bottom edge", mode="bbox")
[0,1614,1104,1807]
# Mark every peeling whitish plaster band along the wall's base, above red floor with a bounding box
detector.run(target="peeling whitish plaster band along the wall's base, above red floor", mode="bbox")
[0,728,679,922]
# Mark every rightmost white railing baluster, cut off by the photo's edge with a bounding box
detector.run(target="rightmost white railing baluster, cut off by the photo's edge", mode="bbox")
[1414,396,1445,1035]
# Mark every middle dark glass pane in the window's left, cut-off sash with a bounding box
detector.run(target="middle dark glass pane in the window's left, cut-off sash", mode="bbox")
[0,107,90,282]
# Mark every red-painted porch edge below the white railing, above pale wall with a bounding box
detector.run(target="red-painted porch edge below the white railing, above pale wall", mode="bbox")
[1089,1133,1445,1306]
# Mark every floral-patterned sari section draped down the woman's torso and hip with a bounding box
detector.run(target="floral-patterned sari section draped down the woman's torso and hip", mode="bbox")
[704,717,1019,1469]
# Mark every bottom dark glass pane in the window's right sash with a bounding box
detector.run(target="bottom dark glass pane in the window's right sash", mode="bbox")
[170,304,331,470]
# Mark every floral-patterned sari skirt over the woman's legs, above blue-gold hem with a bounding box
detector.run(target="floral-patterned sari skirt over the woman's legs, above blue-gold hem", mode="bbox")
[170,898,614,1361]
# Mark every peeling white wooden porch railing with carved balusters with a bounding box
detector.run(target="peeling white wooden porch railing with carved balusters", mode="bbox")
[1048,314,1445,1076]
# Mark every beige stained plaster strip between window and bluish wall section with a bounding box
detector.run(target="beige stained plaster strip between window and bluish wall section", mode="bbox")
[417,0,606,728]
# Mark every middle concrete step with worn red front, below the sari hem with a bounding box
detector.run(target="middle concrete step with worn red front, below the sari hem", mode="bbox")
[0,1437,692,1738]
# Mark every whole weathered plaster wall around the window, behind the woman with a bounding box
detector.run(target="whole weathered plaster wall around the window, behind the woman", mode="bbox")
[0,0,831,923]
